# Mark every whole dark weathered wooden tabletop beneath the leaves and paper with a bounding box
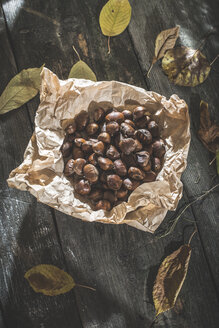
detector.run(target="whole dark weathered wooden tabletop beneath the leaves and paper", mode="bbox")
[0,0,219,328]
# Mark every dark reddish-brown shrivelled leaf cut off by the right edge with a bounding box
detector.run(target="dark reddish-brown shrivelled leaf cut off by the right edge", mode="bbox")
[198,100,219,153]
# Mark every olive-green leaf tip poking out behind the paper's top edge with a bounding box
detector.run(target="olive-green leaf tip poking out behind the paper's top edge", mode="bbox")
[68,60,97,82]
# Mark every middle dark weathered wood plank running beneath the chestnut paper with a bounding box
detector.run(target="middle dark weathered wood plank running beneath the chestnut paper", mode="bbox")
[1,0,219,328]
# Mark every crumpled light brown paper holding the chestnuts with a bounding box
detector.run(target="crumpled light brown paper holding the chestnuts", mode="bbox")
[8,68,190,232]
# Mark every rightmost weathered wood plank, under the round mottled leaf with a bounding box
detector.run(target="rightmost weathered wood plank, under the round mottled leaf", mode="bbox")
[129,0,219,292]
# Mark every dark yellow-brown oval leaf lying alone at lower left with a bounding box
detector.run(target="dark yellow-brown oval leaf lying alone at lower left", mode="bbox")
[24,264,75,296]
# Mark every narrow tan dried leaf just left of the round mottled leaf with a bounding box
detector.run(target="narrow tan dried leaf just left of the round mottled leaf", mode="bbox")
[147,26,180,76]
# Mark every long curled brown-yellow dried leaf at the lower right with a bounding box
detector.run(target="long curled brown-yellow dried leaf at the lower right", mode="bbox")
[153,245,191,315]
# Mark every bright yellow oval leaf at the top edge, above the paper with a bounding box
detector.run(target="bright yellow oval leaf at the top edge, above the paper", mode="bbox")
[99,0,132,36]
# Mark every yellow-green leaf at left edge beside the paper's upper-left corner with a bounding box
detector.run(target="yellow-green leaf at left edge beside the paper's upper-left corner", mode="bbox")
[0,65,44,114]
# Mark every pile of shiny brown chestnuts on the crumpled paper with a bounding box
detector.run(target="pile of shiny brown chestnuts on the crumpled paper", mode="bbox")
[61,106,165,211]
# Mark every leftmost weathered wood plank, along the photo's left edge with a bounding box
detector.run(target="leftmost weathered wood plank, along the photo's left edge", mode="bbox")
[0,5,81,328]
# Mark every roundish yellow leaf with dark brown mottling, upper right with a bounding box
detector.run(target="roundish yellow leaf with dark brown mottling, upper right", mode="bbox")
[162,47,211,87]
